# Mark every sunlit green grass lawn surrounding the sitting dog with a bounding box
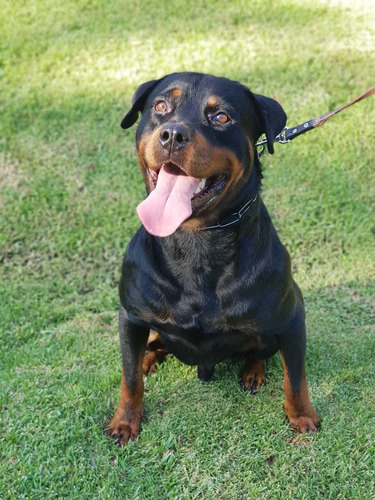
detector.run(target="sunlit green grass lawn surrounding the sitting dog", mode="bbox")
[0,0,375,500]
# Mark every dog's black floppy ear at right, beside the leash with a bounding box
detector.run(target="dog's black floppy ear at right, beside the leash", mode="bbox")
[253,94,286,155]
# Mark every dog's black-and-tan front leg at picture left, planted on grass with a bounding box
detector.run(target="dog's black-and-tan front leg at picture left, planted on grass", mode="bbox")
[108,307,149,446]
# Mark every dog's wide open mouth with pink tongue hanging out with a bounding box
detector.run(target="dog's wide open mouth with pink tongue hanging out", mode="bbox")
[137,162,229,236]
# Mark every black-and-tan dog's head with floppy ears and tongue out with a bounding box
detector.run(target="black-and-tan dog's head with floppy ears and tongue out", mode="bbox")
[121,73,286,236]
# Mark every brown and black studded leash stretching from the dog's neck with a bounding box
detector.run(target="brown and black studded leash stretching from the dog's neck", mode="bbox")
[255,85,375,158]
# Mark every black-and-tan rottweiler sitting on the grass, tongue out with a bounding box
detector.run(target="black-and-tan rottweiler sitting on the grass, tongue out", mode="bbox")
[109,73,320,445]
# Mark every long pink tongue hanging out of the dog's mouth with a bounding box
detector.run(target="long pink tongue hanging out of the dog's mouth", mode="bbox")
[137,165,201,236]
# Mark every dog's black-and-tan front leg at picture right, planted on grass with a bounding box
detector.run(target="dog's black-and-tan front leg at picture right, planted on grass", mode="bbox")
[277,313,321,433]
